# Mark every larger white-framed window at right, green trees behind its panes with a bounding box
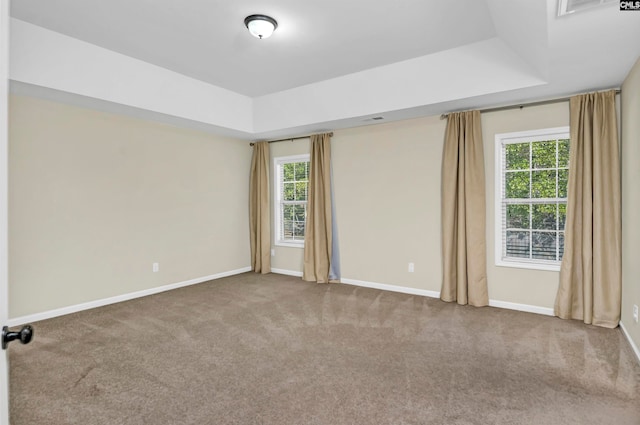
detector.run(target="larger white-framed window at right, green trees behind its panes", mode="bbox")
[495,127,569,270]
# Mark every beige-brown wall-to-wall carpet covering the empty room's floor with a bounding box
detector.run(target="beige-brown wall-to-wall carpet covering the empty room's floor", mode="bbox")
[10,273,640,425]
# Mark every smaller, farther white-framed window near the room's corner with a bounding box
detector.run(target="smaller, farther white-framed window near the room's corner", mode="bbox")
[274,155,309,247]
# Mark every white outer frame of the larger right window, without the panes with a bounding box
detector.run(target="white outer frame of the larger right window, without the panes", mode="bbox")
[494,126,571,271]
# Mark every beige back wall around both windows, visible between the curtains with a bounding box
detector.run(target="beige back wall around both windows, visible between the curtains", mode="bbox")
[271,102,569,308]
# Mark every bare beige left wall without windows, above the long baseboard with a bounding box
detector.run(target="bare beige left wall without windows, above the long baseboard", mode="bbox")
[9,96,251,318]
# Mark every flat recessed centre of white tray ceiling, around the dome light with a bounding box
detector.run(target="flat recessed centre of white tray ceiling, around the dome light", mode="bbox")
[11,0,495,96]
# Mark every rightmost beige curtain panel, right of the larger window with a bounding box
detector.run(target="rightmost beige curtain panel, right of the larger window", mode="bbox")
[555,90,622,328]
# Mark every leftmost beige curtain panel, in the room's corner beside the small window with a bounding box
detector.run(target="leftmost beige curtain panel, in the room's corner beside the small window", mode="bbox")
[249,142,271,274]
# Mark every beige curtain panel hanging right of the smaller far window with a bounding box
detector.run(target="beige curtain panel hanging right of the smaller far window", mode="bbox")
[302,134,333,283]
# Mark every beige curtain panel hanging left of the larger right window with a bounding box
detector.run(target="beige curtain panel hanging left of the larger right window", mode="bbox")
[440,111,489,307]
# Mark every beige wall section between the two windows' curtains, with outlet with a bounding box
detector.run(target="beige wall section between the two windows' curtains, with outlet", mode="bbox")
[332,117,445,291]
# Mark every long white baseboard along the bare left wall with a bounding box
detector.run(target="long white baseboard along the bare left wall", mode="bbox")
[7,267,251,326]
